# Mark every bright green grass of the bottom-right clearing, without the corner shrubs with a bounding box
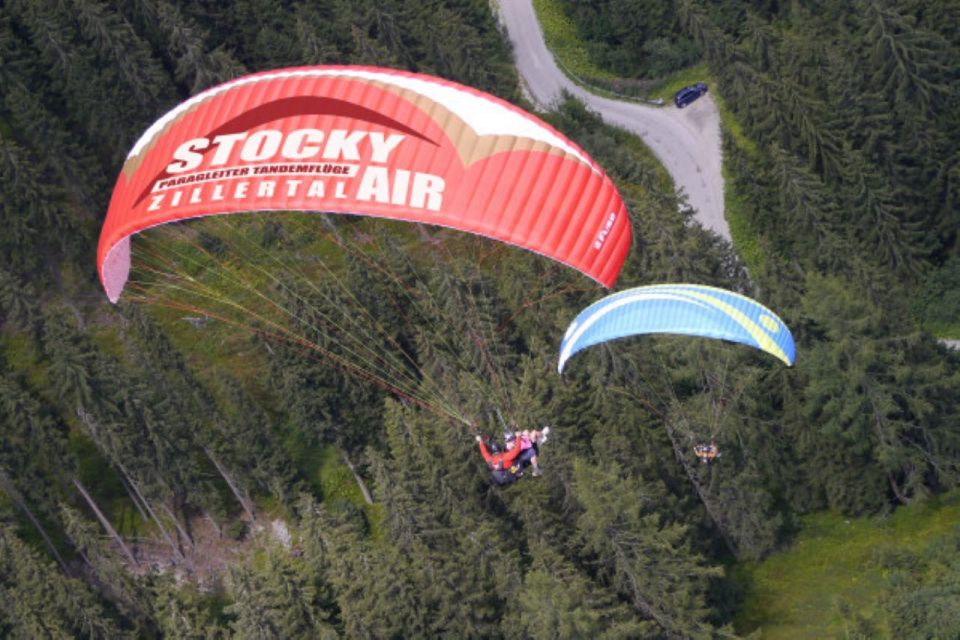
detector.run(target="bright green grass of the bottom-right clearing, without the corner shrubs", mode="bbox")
[733,493,960,640]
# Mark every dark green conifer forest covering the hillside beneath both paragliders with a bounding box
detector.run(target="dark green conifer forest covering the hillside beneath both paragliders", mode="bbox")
[0,0,960,639]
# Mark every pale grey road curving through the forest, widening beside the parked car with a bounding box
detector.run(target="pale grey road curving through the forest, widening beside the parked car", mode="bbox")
[496,0,730,240]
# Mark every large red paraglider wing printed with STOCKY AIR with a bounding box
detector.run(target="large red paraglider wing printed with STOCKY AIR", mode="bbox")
[97,67,630,302]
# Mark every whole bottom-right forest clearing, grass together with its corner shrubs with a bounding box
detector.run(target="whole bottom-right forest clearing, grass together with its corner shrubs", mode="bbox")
[735,494,960,638]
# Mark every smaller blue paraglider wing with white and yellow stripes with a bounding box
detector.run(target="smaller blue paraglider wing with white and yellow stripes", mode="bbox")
[557,284,796,373]
